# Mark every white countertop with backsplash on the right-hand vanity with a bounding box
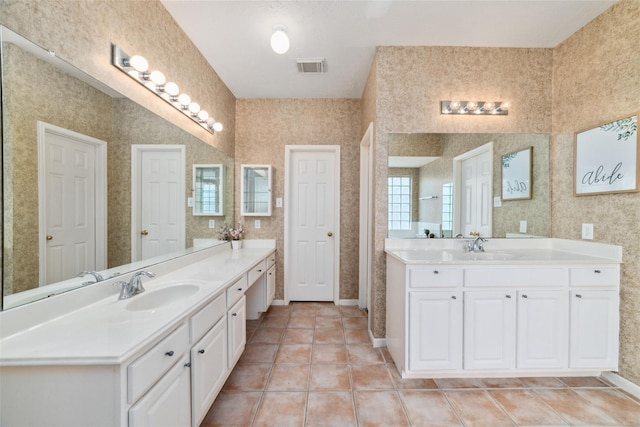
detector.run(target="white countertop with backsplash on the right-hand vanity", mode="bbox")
[385,239,622,265]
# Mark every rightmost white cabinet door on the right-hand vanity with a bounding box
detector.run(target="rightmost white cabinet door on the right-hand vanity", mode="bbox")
[569,290,619,371]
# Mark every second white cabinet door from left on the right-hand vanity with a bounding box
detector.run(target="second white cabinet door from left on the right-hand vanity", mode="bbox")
[464,291,516,369]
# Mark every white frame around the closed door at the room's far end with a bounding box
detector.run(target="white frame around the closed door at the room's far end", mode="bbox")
[284,145,341,305]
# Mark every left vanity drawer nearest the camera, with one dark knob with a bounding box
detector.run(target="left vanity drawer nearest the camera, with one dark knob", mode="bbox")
[127,324,189,403]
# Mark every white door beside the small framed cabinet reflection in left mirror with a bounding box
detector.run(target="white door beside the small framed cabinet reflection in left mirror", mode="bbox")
[131,145,185,261]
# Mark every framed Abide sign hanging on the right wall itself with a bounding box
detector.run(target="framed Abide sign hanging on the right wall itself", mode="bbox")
[574,114,639,196]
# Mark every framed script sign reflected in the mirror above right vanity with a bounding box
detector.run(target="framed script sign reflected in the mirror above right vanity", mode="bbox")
[502,147,533,200]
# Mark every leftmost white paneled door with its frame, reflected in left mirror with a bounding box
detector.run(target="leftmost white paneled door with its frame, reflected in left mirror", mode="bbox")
[38,122,106,286]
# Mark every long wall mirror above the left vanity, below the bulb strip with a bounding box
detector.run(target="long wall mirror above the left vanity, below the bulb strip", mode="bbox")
[0,27,234,309]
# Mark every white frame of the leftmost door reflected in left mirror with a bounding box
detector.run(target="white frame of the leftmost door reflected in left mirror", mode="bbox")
[37,120,108,286]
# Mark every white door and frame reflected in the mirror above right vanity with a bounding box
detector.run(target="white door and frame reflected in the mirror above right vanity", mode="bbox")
[454,143,493,237]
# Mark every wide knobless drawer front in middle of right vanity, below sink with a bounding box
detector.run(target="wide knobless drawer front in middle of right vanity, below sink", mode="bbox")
[464,266,569,287]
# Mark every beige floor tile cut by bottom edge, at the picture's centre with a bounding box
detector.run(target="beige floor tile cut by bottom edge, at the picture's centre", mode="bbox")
[306,391,357,427]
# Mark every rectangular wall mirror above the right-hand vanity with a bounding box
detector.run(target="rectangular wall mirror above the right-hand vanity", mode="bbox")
[388,133,550,238]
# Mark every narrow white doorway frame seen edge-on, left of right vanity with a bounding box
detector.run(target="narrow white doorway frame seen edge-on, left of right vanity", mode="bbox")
[358,122,374,311]
